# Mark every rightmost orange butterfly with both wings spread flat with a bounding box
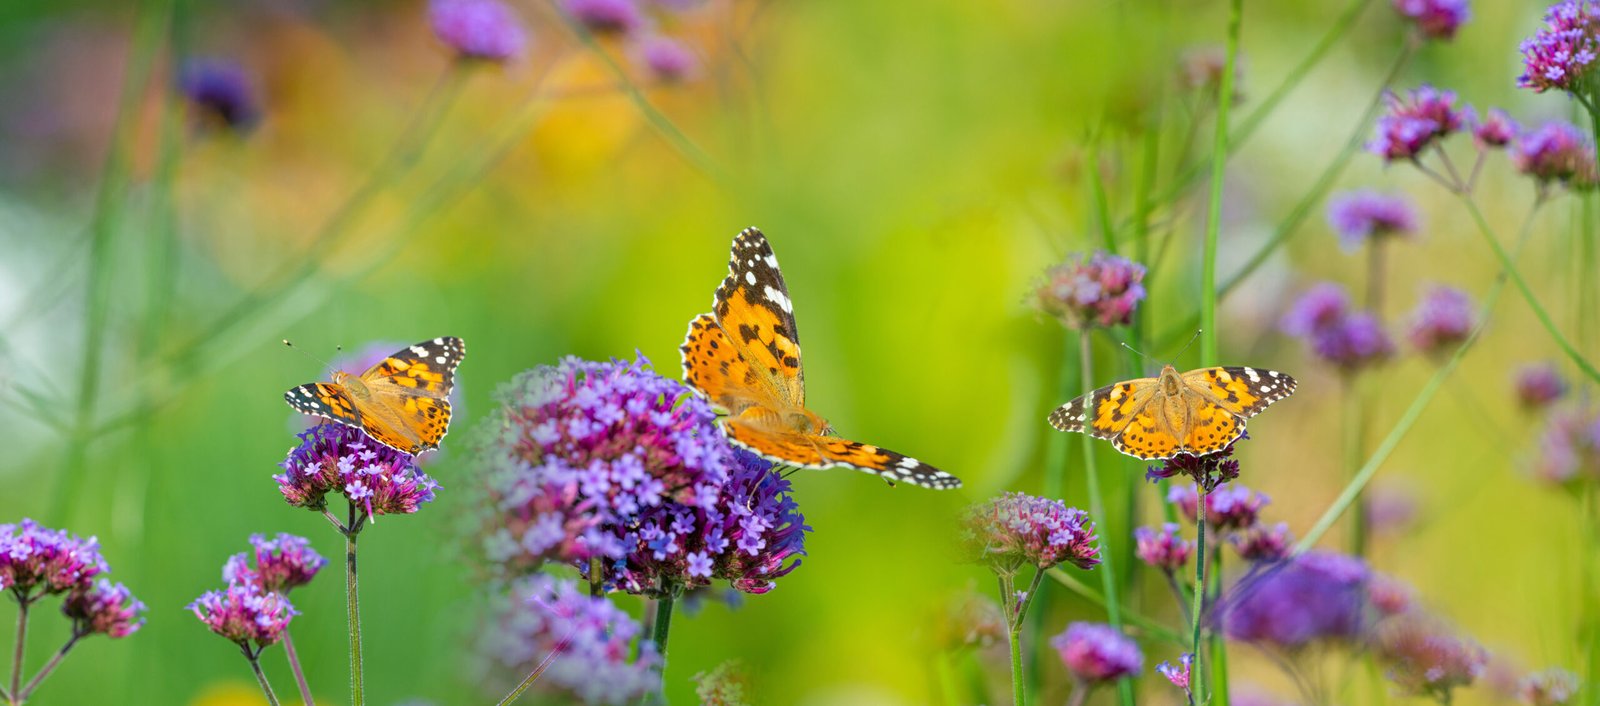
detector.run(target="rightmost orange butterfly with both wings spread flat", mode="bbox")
[1050,365,1296,459]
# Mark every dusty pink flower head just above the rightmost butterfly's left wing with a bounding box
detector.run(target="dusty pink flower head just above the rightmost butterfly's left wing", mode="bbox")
[1034,253,1144,328]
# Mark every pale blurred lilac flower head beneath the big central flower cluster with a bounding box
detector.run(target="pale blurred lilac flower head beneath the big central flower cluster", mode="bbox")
[478,575,661,704]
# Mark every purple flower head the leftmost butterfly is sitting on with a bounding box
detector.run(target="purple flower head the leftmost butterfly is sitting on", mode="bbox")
[272,423,438,515]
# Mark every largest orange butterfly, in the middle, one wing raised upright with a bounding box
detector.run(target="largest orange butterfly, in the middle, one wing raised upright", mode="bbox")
[678,227,962,490]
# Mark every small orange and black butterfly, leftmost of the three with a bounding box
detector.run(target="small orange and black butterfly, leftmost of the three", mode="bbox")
[283,336,467,455]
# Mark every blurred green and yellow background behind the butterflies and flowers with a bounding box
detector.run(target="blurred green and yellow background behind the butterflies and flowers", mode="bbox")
[0,0,1600,704]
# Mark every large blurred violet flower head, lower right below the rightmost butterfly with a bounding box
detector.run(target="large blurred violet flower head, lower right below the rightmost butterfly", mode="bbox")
[1216,551,1368,652]
